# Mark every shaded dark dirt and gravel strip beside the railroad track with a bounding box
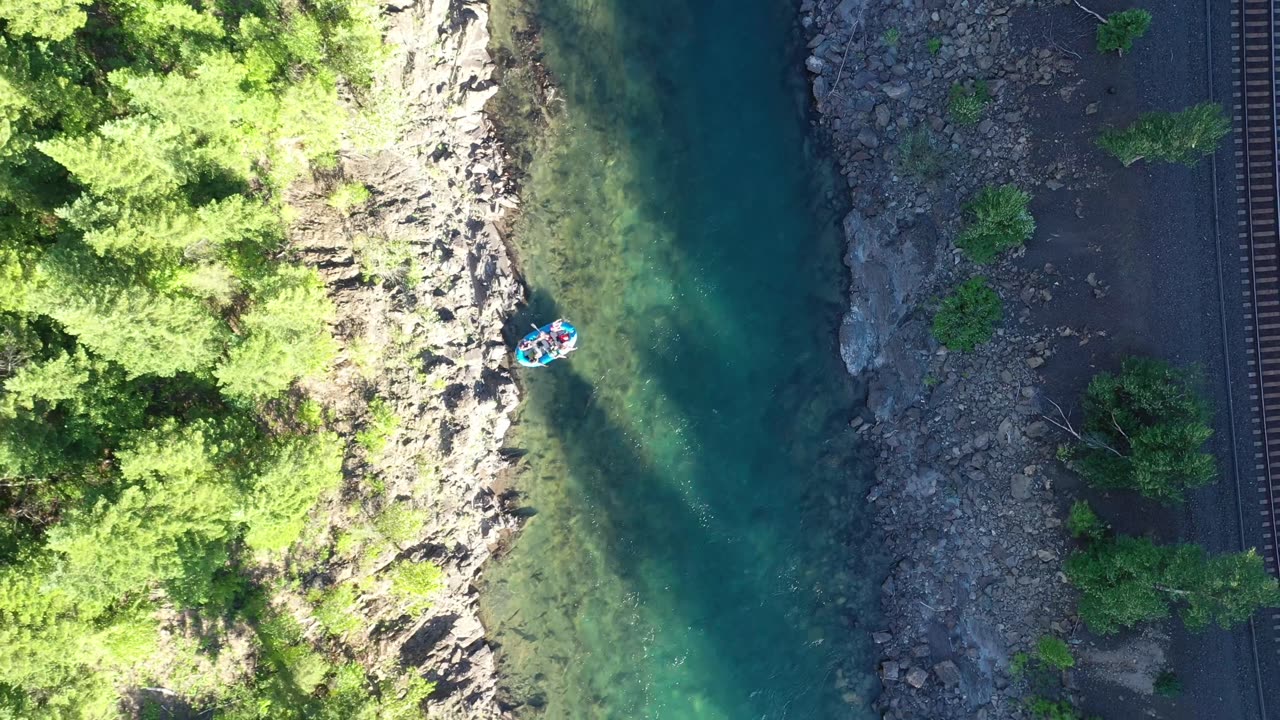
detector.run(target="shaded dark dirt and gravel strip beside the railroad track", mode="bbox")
[1014,0,1280,720]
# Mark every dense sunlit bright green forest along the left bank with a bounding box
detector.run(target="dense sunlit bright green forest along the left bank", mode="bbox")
[0,0,442,719]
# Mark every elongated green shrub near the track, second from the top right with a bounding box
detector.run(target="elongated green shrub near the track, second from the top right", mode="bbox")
[1097,102,1231,167]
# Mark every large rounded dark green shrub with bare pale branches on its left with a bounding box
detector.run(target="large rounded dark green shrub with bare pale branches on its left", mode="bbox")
[1071,357,1217,502]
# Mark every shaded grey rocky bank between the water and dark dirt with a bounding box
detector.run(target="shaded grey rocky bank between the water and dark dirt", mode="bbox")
[801,0,1088,720]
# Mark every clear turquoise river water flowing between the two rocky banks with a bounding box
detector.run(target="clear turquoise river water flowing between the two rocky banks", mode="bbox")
[481,0,878,720]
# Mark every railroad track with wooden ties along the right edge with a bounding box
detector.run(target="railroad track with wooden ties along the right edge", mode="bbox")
[1224,0,1280,650]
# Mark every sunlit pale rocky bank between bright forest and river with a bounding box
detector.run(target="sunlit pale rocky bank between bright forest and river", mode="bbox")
[291,0,522,719]
